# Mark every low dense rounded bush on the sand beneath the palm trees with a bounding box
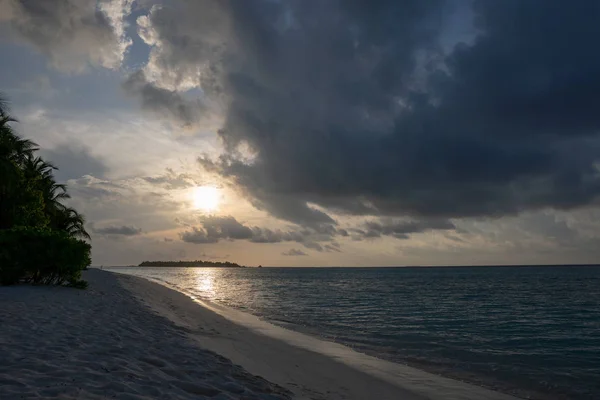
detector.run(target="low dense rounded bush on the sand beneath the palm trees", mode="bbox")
[0,227,91,288]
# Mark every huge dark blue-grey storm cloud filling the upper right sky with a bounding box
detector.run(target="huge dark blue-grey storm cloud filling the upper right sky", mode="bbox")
[134,0,600,228]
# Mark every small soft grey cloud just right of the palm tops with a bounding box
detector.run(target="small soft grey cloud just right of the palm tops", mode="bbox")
[40,143,108,181]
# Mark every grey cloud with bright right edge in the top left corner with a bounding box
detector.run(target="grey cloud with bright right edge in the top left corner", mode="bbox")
[0,0,133,72]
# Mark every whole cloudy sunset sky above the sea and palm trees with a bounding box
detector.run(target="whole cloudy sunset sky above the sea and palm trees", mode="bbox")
[0,0,600,266]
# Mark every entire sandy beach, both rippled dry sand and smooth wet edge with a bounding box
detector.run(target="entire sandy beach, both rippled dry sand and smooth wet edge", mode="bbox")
[0,270,514,400]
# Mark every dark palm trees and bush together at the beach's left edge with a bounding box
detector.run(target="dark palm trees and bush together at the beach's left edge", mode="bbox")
[0,94,91,288]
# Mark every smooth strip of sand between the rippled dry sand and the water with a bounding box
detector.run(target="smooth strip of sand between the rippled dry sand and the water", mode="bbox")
[117,273,517,400]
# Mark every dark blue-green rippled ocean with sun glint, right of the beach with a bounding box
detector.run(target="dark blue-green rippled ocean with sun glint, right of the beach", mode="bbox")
[111,266,600,399]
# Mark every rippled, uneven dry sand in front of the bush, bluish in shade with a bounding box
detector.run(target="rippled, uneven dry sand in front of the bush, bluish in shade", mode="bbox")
[0,270,289,400]
